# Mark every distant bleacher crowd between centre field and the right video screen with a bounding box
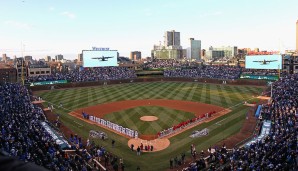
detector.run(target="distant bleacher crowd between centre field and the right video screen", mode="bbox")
[164,65,241,79]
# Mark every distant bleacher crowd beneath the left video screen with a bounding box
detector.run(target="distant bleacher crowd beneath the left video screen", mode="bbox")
[27,67,136,82]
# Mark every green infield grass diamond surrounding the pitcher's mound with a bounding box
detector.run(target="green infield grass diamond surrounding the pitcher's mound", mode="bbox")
[104,106,195,135]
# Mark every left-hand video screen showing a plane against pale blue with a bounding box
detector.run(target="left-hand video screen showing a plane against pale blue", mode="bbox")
[82,50,118,67]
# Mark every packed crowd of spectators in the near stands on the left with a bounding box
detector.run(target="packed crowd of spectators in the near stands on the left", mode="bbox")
[0,83,124,171]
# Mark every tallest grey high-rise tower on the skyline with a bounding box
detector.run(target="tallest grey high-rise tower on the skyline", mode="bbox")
[164,30,181,49]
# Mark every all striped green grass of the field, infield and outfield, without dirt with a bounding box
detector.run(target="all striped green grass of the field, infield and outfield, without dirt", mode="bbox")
[36,82,264,170]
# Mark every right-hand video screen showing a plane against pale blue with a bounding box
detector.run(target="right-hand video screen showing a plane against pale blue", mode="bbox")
[245,55,282,69]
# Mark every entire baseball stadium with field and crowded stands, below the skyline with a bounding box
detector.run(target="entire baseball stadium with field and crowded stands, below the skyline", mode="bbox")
[1,55,298,171]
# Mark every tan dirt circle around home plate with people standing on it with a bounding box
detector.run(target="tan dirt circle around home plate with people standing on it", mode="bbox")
[127,138,170,152]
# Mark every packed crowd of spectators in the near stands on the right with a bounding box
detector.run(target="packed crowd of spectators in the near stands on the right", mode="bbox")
[184,74,298,171]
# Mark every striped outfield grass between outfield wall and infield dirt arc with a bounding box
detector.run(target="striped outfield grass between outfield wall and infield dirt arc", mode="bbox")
[39,82,262,110]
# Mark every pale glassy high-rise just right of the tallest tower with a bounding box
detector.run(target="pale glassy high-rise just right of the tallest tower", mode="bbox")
[187,38,201,60]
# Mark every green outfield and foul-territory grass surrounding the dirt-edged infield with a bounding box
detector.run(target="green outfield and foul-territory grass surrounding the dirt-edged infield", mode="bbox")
[37,82,263,170]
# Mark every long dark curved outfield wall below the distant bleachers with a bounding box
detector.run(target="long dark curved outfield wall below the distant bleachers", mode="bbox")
[28,77,267,91]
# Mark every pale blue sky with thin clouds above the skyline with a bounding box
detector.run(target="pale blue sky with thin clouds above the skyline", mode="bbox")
[0,0,298,59]
